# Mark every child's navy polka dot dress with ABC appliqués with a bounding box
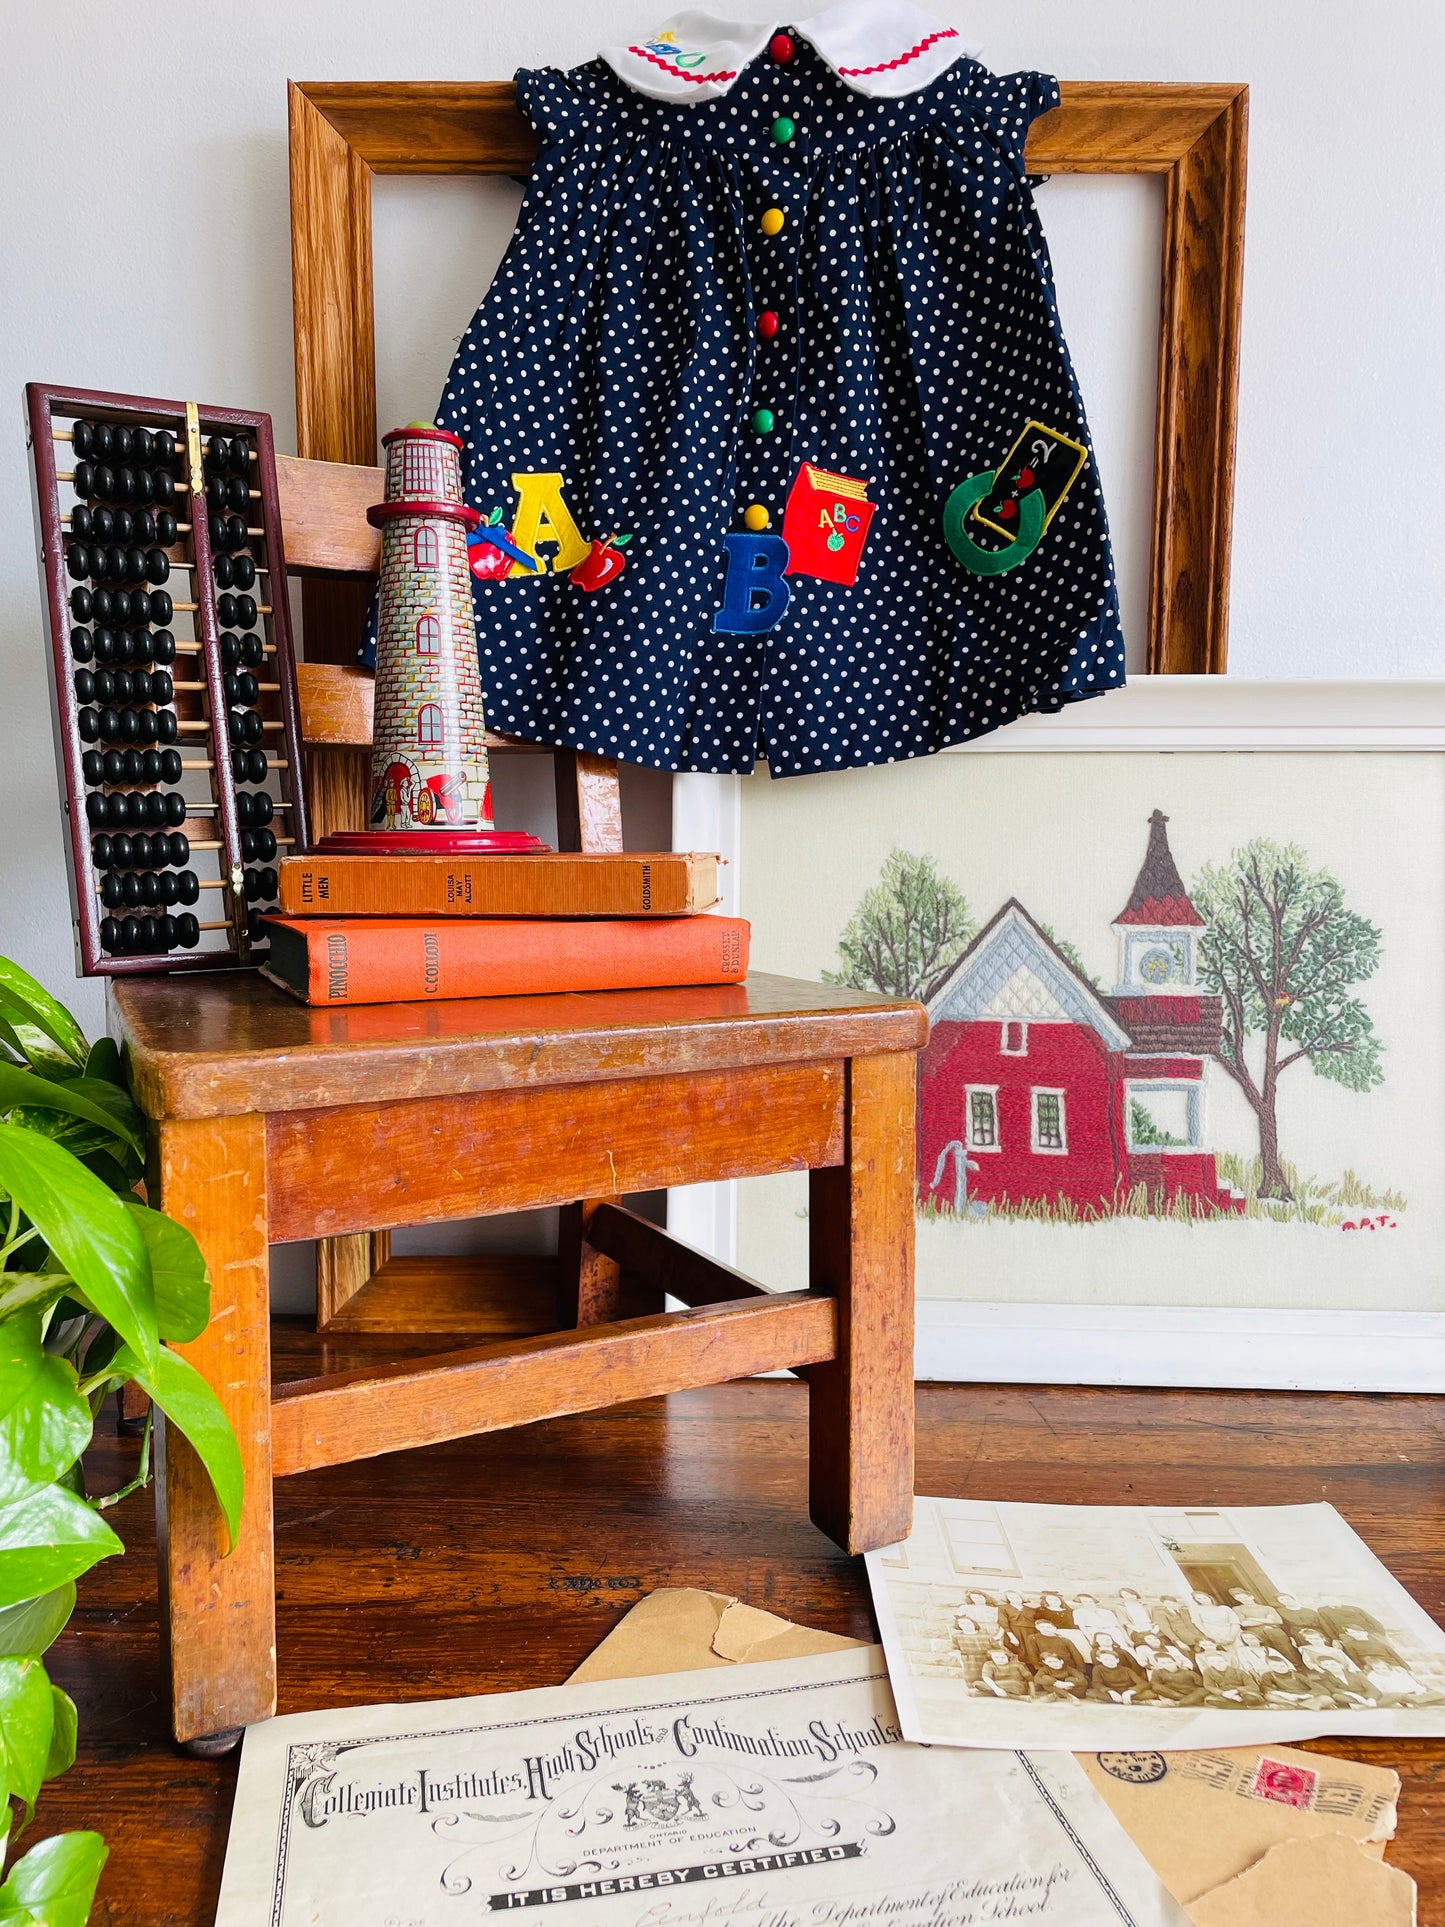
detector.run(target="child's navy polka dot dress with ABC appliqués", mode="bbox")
[410,17,1123,777]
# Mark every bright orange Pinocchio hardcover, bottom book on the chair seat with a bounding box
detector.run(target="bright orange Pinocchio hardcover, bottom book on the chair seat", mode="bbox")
[262,917,749,1004]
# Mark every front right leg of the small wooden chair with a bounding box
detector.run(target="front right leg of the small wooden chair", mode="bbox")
[807,1052,915,1553]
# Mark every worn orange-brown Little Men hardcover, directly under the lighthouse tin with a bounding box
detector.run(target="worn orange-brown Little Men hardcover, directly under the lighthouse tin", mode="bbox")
[276,850,719,917]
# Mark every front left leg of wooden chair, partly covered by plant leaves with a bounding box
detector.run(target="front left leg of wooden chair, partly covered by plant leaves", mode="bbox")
[152,1114,276,1752]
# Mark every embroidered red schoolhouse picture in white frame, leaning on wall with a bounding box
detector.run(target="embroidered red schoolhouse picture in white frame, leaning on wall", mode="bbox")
[678,676,1445,1389]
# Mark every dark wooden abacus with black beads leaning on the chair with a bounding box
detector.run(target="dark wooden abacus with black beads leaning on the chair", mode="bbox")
[25,382,310,977]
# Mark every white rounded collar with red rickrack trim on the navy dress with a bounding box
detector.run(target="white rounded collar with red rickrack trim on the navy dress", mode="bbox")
[601,0,981,100]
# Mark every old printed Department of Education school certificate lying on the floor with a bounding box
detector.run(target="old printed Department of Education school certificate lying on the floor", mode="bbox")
[216,1648,1187,1927]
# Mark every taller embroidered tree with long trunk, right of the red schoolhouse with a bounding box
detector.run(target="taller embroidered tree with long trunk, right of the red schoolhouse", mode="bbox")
[1191,836,1383,1201]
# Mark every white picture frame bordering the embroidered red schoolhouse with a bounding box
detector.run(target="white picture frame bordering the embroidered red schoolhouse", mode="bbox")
[669,676,1445,1393]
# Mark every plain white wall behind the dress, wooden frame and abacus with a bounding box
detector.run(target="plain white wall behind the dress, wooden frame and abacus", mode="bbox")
[0,0,1445,1264]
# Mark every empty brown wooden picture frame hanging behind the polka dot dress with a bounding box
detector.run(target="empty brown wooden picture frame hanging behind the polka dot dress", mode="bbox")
[291,81,1248,674]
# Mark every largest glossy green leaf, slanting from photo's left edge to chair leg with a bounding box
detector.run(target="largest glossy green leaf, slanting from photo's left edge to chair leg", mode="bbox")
[0,1123,158,1387]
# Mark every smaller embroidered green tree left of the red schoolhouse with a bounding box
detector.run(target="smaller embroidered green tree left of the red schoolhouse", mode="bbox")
[823,850,977,1004]
